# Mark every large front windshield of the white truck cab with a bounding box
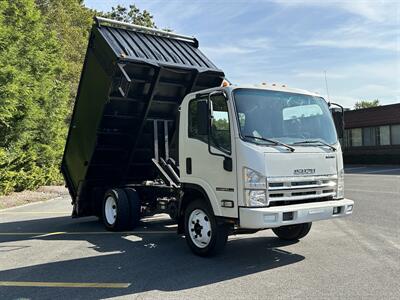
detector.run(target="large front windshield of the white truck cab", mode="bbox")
[234,89,337,145]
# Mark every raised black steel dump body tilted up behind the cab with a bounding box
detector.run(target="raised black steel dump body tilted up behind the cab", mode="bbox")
[61,18,224,216]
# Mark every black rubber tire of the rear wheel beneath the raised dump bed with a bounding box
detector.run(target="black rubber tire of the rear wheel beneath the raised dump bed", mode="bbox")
[102,189,131,231]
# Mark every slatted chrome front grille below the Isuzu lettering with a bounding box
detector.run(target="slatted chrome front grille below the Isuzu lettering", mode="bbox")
[267,175,337,206]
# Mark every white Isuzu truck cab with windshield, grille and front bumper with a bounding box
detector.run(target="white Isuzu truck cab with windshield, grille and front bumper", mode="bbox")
[179,85,354,254]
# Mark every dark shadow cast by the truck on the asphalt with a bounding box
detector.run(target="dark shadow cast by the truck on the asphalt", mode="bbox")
[0,217,304,299]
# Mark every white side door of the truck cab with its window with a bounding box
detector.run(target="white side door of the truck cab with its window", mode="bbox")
[179,92,238,218]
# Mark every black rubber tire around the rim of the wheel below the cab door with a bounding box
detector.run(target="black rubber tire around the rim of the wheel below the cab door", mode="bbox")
[184,199,229,256]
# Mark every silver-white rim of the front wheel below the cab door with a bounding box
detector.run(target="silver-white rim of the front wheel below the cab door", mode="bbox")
[188,208,212,248]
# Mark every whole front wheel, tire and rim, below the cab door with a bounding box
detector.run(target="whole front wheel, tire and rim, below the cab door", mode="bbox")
[185,199,228,256]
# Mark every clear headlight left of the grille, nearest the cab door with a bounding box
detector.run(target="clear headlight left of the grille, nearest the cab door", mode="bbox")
[243,168,268,206]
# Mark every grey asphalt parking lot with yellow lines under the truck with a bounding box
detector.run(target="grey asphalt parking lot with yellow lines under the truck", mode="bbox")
[0,166,400,299]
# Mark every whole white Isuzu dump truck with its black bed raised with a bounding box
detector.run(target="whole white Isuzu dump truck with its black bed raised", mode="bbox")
[61,17,354,256]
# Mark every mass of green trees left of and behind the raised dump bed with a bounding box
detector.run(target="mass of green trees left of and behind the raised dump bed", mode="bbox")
[0,0,159,195]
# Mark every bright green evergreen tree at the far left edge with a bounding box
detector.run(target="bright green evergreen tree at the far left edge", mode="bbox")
[0,0,67,193]
